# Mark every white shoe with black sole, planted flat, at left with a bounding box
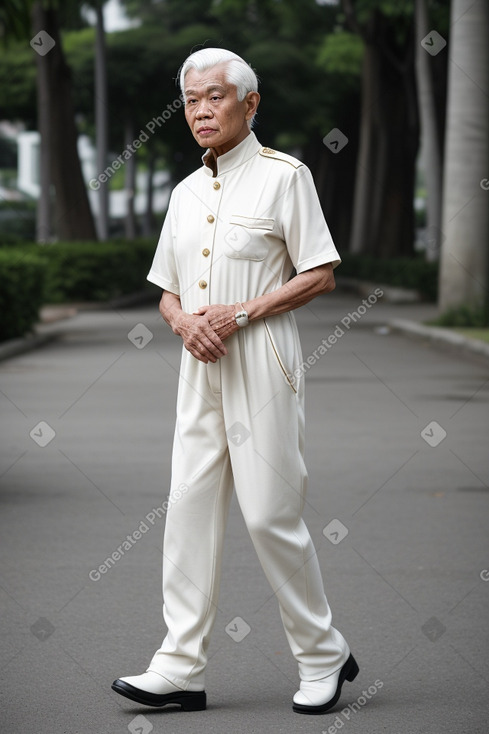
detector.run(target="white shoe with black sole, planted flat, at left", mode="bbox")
[112,671,206,711]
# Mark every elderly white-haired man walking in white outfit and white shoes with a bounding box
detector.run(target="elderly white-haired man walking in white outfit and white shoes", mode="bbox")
[112,48,358,714]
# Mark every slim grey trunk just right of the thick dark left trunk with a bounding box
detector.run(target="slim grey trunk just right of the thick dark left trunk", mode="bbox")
[95,3,109,240]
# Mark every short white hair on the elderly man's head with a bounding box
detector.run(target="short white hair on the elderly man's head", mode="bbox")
[179,48,258,102]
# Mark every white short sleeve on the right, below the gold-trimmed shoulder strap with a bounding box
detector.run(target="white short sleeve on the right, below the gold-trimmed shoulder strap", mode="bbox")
[282,165,341,273]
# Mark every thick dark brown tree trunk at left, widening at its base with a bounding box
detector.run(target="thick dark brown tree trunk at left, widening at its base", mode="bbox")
[33,2,96,240]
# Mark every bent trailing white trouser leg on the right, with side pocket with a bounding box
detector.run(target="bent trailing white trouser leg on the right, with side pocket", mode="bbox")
[223,320,349,680]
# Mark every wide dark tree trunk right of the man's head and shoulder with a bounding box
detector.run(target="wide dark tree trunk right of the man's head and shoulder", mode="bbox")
[347,9,419,257]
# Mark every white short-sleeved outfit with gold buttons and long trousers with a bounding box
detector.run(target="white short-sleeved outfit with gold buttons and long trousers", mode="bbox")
[148,133,349,689]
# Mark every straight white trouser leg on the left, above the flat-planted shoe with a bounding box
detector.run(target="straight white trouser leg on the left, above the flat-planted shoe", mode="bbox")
[148,354,232,688]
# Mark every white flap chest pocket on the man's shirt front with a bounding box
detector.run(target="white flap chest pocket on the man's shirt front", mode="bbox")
[224,214,275,262]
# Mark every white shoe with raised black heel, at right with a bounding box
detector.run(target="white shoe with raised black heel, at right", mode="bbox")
[292,654,359,714]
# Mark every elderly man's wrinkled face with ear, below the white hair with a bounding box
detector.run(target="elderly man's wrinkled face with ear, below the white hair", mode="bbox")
[185,64,260,155]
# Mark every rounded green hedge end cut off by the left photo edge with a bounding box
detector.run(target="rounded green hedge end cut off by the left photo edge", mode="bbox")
[0,248,47,341]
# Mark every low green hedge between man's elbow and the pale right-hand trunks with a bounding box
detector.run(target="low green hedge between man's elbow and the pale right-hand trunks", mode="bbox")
[338,253,438,301]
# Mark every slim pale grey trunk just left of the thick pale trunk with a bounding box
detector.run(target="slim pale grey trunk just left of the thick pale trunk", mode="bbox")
[415,0,442,261]
